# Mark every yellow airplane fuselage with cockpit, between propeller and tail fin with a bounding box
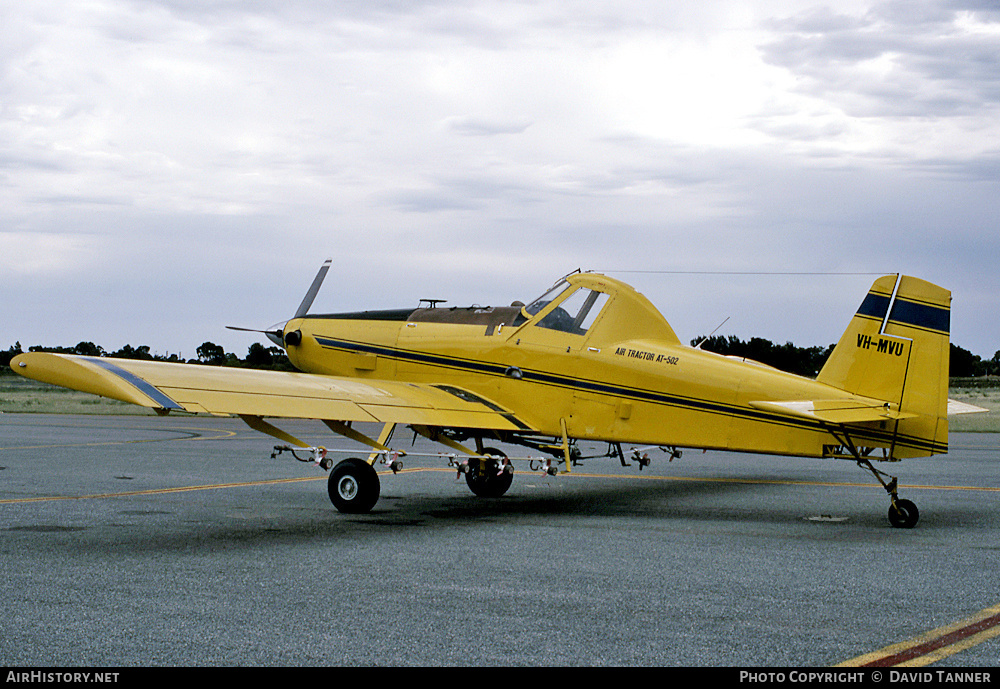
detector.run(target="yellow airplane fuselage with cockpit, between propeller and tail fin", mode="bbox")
[285,274,897,456]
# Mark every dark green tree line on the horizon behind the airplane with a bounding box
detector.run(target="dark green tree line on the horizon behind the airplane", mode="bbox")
[0,335,1000,378]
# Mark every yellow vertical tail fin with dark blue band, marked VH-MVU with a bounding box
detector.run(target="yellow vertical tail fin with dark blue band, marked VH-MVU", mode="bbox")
[817,275,951,456]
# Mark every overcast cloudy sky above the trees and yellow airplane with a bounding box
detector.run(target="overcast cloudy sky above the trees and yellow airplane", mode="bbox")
[0,0,1000,358]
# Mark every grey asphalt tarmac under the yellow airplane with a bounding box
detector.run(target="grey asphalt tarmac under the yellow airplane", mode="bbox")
[0,414,1000,667]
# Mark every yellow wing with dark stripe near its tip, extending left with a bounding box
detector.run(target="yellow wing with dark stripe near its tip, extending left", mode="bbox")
[11,352,530,430]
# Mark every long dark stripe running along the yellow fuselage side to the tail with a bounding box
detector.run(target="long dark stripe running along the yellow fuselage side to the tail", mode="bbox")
[316,336,947,453]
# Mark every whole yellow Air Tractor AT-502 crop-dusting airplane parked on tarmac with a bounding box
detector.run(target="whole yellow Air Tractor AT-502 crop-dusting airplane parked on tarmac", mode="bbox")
[11,261,984,527]
